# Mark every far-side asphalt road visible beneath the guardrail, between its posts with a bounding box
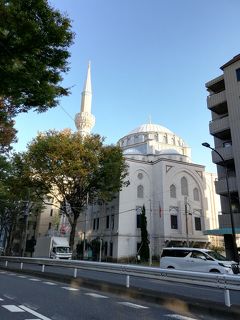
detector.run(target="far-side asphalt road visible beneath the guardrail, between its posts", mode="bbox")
[1,263,240,307]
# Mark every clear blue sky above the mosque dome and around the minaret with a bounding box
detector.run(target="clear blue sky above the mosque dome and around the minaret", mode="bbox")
[14,0,240,172]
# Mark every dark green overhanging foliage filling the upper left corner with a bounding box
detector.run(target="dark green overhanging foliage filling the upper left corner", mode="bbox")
[0,0,73,150]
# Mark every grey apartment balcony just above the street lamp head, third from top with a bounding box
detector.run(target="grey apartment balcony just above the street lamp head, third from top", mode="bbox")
[209,116,230,139]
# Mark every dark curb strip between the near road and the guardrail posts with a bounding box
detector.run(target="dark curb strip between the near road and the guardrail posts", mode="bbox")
[1,267,240,320]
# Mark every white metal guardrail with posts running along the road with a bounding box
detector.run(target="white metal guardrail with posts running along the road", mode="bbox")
[0,256,240,307]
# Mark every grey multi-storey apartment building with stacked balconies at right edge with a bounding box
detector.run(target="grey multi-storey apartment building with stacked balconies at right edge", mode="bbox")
[206,54,240,259]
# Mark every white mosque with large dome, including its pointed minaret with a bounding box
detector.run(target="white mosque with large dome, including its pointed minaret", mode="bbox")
[71,64,220,261]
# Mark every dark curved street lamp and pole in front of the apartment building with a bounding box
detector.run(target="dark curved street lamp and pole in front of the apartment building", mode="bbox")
[202,142,239,263]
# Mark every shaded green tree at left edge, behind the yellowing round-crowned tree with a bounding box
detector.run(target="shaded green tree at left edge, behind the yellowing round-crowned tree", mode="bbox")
[0,154,42,254]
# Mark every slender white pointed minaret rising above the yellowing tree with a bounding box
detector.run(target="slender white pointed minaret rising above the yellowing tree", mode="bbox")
[75,62,95,136]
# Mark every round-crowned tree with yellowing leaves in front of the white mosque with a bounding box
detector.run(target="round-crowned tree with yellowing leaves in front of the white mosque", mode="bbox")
[26,130,127,249]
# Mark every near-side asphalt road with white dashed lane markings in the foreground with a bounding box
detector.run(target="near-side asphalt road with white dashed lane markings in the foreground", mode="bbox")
[0,271,217,320]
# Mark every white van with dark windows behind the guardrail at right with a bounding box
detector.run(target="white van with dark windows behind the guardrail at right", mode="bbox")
[160,248,239,274]
